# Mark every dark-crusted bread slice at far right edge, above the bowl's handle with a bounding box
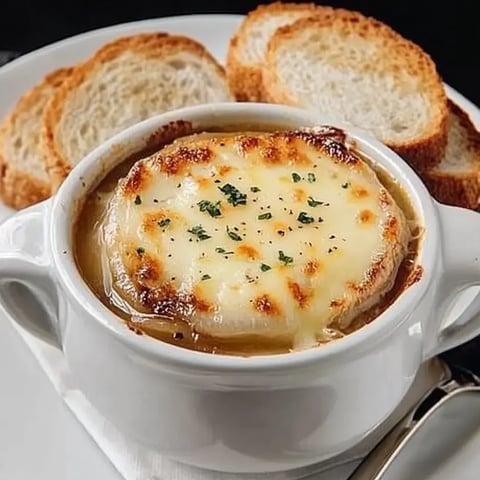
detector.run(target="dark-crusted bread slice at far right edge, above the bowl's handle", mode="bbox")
[422,102,480,209]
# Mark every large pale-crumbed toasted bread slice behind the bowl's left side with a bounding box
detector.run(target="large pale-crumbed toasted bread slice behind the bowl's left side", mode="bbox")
[43,33,234,191]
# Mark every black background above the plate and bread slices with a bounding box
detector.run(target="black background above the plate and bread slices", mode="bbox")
[0,0,480,104]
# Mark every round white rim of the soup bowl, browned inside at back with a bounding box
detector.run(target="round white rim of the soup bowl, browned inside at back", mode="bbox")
[47,103,440,373]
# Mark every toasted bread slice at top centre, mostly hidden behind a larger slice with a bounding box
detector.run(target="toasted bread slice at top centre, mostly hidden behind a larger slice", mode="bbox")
[227,2,330,102]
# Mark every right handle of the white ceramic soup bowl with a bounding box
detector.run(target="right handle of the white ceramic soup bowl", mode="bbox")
[425,205,480,358]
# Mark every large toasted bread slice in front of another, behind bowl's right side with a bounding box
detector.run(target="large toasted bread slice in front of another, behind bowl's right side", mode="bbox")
[263,10,448,171]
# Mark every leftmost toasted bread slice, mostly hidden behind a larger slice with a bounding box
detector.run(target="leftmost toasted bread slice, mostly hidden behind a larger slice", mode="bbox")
[0,68,72,209]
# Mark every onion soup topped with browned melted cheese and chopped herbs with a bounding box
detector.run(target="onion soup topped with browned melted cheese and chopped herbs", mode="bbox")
[74,127,421,355]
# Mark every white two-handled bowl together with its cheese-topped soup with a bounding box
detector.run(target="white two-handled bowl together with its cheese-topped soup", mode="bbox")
[0,103,480,473]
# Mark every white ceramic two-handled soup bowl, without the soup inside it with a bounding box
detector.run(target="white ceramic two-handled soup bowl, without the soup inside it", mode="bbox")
[0,104,480,472]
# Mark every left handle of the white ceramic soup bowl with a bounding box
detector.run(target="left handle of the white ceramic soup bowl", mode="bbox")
[0,201,61,346]
